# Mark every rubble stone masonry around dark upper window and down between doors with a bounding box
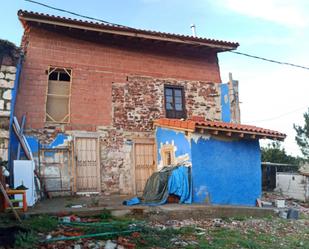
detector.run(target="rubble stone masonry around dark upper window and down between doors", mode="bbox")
[97,76,221,194]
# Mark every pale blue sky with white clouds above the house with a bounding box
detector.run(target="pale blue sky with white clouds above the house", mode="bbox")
[0,0,309,155]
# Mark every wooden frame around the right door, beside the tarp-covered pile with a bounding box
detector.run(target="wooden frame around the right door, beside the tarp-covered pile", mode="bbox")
[131,137,158,195]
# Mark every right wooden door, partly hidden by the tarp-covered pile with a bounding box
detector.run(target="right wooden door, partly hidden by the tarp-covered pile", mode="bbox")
[134,139,156,195]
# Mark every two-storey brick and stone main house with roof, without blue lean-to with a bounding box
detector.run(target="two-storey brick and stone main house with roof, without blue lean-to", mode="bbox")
[15,10,240,194]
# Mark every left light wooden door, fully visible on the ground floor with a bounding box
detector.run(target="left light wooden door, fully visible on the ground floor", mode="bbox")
[75,137,101,192]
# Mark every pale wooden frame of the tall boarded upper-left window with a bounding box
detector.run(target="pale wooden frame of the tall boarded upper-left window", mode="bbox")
[44,65,73,124]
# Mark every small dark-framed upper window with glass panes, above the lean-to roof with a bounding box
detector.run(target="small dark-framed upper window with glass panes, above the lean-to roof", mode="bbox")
[164,86,186,118]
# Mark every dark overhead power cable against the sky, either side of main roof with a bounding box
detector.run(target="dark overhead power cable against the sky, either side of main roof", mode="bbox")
[25,0,309,70]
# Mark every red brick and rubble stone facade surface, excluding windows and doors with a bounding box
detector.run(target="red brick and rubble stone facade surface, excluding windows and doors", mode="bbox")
[16,27,226,194]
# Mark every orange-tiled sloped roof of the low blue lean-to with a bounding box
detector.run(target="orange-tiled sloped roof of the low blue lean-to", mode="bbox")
[154,118,286,140]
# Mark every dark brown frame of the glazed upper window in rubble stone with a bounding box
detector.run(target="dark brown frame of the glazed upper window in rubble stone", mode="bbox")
[164,84,187,119]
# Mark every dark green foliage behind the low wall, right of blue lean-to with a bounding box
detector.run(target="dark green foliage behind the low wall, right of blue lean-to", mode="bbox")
[261,142,301,165]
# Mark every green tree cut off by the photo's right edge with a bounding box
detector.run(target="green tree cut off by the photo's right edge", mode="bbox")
[294,108,309,159]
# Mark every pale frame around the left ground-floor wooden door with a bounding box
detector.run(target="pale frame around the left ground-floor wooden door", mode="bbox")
[73,132,102,193]
